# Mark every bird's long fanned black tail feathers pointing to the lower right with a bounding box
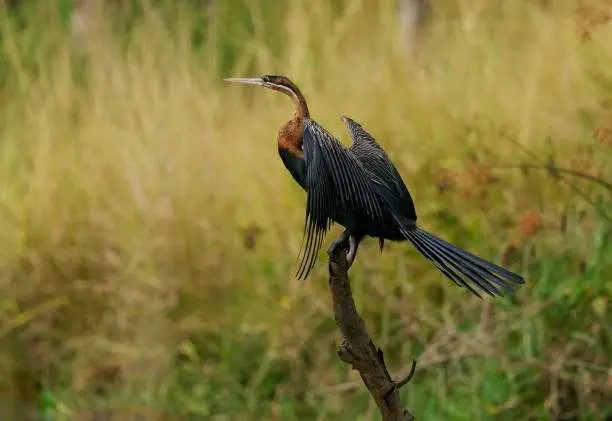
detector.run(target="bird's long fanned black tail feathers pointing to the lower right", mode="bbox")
[402,220,525,297]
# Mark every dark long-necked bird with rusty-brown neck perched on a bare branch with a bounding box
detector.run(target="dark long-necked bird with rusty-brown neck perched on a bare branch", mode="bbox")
[224,74,525,298]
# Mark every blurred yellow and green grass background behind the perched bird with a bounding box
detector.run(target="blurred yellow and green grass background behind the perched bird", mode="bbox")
[0,0,612,421]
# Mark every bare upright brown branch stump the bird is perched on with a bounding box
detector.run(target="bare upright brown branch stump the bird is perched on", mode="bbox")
[328,240,416,421]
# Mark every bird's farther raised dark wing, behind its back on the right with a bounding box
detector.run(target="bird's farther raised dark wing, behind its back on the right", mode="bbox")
[342,116,417,221]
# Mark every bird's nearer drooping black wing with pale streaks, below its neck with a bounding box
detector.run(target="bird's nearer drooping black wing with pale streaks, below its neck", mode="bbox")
[298,119,383,279]
